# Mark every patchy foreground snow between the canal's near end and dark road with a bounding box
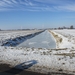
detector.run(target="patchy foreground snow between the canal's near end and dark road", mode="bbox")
[0,47,75,73]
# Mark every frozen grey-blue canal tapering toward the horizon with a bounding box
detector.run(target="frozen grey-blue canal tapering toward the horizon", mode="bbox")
[18,30,56,49]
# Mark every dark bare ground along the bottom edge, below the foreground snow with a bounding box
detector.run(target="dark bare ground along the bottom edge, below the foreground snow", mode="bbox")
[0,64,74,75]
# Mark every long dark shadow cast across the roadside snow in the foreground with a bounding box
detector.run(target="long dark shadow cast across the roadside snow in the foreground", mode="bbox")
[0,60,37,75]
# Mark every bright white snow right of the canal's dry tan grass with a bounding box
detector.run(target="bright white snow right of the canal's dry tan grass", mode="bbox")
[53,30,75,49]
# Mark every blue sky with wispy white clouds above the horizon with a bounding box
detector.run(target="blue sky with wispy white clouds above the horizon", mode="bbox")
[0,0,75,29]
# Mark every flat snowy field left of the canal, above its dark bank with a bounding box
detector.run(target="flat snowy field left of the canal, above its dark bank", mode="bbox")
[0,30,40,45]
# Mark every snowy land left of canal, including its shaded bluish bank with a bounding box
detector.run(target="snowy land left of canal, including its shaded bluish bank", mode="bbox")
[0,30,42,46]
